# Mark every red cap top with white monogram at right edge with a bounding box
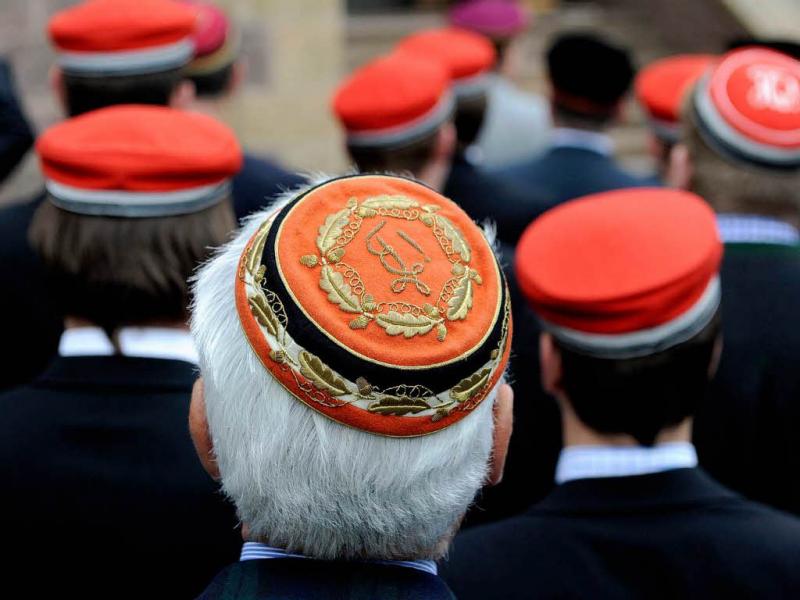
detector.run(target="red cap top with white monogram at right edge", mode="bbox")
[709,48,800,149]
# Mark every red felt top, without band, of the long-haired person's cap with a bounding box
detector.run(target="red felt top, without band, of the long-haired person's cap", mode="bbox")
[36,105,242,192]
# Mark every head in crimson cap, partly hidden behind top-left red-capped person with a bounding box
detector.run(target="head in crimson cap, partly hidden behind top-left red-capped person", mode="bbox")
[182,0,244,100]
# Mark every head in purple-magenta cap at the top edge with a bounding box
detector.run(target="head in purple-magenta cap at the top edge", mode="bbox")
[448,0,530,75]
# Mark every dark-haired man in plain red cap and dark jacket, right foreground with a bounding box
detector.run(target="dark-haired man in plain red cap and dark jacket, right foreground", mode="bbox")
[443,190,800,600]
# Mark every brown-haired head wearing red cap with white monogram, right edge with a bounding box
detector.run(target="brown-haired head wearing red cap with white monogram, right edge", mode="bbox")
[670,48,800,223]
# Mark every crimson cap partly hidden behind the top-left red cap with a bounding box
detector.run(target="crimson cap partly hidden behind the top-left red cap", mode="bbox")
[182,0,240,76]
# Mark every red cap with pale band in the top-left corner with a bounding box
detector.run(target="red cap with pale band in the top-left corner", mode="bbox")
[48,0,196,77]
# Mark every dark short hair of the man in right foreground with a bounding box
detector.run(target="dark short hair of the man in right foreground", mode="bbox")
[555,312,721,446]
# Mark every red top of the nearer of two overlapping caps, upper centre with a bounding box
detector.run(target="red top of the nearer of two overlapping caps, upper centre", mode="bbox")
[332,54,450,131]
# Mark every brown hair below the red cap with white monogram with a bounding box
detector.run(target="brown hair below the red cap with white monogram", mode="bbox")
[683,112,800,218]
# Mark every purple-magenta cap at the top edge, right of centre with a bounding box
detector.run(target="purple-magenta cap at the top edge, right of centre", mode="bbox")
[448,0,530,39]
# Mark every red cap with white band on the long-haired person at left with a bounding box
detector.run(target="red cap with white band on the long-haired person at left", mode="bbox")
[36,105,242,217]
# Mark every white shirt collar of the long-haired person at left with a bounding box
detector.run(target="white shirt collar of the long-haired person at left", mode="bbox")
[58,327,198,364]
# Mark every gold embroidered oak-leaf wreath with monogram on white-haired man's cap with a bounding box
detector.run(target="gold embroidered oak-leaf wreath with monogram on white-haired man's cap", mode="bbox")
[300,195,482,342]
